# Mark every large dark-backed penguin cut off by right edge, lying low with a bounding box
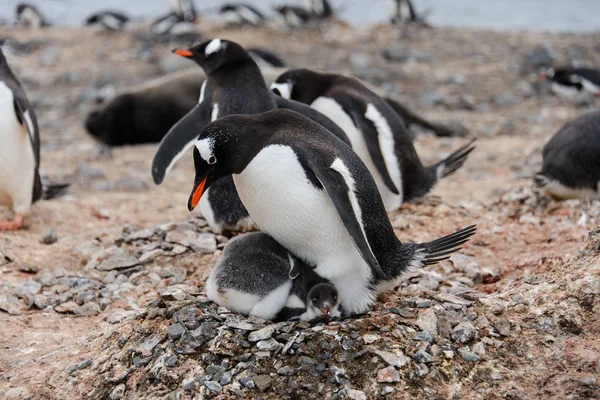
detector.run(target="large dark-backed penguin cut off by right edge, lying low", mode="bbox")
[534,111,600,200]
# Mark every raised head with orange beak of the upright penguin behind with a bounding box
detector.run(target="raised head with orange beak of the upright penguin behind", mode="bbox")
[173,38,253,75]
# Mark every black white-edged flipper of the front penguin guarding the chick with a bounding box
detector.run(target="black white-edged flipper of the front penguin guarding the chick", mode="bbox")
[303,154,386,279]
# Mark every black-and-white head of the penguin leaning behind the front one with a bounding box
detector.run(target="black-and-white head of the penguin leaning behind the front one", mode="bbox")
[271,69,329,104]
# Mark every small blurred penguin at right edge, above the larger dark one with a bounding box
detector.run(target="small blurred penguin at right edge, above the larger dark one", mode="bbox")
[542,68,600,99]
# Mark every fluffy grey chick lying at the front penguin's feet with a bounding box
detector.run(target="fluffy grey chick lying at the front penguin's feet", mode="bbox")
[206,232,341,320]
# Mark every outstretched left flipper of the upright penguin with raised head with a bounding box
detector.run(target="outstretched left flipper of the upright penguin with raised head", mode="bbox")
[152,104,211,185]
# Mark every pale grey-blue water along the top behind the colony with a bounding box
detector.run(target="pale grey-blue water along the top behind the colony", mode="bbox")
[0,0,600,32]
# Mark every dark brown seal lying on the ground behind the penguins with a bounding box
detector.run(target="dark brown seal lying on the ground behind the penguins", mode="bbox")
[84,67,466,146]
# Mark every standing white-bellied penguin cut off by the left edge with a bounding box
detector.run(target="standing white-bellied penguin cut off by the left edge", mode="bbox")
[0,50,68,230]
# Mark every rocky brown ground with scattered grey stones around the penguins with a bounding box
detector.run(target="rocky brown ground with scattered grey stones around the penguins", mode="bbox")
[0,20,600,399]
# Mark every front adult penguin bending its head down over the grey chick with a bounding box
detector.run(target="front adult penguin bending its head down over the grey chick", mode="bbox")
[188,110,475,313]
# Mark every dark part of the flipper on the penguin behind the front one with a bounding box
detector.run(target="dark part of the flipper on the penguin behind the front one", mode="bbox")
[331,93,400,195]
